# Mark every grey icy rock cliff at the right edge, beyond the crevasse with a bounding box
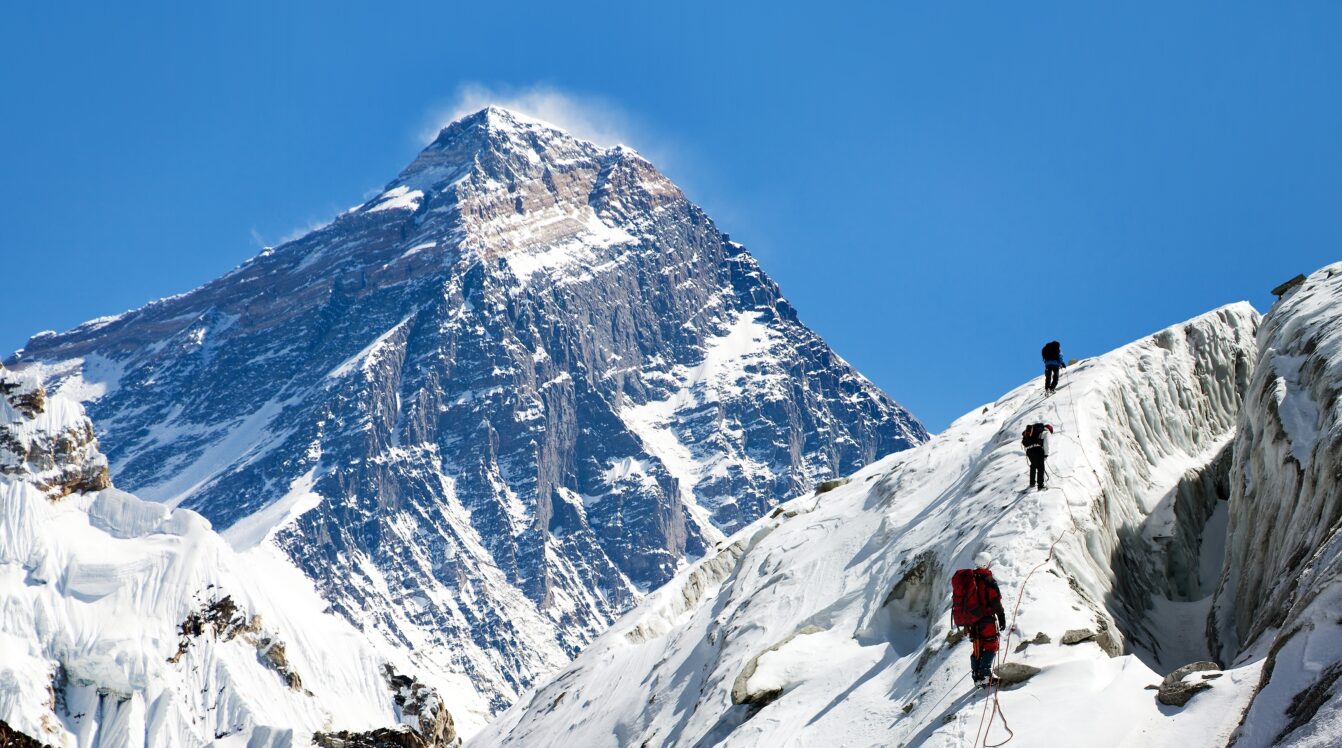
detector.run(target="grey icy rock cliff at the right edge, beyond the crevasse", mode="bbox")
[1212,263,1342,747]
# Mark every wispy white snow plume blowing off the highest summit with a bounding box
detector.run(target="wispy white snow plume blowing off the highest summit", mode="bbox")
[423,83,643,148]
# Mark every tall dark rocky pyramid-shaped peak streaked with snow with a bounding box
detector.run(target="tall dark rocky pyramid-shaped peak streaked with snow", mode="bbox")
[11,107,926,731]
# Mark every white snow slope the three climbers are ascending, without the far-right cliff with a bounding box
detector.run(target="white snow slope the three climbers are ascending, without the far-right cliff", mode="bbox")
[470,303,1260,748]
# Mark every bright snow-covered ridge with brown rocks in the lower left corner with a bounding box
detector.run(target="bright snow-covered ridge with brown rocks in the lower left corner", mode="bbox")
[0,367,458,748]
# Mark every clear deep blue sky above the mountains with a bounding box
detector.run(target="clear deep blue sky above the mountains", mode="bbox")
[0,1,1342,430]
